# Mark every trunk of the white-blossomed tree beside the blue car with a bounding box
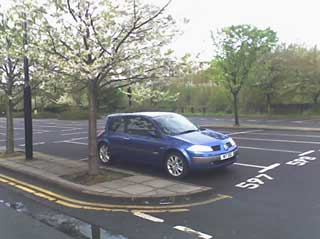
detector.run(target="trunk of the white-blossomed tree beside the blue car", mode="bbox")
[88,80,98,175]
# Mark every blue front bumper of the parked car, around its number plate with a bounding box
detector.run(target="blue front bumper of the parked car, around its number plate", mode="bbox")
[191,148,239,169]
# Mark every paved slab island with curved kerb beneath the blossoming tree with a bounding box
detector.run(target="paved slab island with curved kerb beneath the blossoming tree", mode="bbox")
[0,152,211,202]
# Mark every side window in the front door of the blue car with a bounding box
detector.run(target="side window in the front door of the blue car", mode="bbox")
[127,116,157,137]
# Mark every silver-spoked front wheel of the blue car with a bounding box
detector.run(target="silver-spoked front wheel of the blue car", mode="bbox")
[164,152,189,179]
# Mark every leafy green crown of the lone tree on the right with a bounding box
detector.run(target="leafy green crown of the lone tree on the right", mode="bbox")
[212,25,277,95]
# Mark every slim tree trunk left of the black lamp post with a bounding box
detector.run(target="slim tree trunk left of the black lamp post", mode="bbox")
[6,96,14,154]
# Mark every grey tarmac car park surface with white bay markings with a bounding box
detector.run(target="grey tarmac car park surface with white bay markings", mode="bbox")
[0,116,320,239]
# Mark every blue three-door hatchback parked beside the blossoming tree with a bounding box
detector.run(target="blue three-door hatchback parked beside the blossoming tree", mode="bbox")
[97,112,239,178]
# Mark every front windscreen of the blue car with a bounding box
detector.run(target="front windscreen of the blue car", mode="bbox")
[154,114,199,135]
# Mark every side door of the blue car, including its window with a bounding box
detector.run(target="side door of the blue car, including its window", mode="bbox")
[127,116,165,164]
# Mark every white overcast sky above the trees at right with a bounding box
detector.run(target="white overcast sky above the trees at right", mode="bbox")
[144,0,320,60]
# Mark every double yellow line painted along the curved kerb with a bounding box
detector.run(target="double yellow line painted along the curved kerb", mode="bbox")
[0,174,232,213]
